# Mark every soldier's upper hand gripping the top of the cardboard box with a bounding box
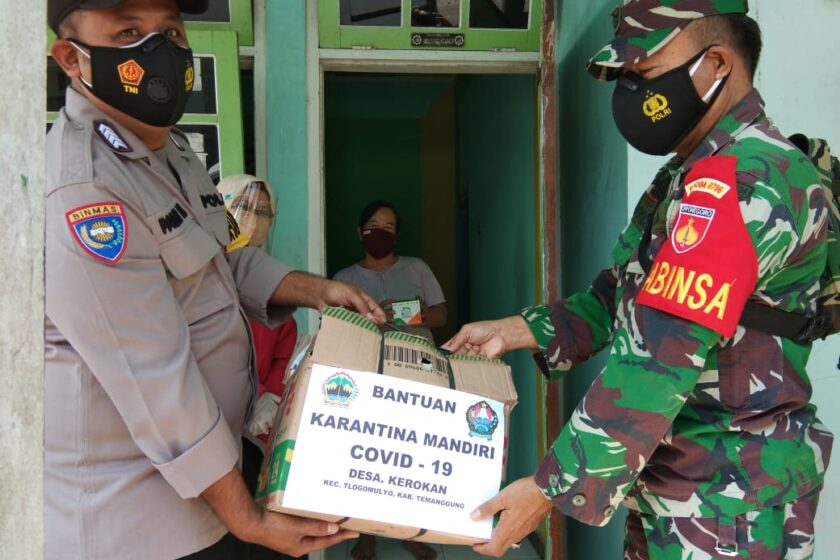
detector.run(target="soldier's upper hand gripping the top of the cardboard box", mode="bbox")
[443,315,537,358]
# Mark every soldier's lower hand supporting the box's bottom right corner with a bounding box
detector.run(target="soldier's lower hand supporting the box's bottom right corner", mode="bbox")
[471,476,551,558]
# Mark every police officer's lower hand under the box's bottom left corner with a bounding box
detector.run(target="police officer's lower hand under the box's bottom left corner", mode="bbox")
[252,511,359,557]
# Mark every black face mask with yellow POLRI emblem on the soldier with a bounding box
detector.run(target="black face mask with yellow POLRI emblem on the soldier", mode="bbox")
[613,47,729,156]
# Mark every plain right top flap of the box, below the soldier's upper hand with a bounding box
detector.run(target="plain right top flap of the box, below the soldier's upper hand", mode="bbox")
[449,354,518,408]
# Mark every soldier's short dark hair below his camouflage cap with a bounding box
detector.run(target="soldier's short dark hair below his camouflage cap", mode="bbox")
[691,14,763,78]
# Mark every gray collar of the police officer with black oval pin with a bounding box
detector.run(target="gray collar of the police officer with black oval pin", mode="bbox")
[64,87,156,159]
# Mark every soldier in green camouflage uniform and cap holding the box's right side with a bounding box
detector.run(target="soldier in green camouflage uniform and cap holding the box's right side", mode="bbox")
[447,0,832,560]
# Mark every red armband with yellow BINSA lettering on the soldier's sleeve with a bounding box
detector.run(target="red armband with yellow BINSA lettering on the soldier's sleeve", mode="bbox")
[636,156,758,337]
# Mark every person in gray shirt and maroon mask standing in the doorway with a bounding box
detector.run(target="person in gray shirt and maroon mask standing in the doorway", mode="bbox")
[335,200,446,560]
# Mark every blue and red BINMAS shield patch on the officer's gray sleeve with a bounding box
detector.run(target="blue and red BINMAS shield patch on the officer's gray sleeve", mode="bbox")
[65,202,128,265]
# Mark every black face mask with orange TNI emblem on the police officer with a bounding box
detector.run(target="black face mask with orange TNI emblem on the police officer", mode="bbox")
[70,33,195,127]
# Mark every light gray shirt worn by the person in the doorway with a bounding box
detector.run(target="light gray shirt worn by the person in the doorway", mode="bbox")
[334,257,446,341]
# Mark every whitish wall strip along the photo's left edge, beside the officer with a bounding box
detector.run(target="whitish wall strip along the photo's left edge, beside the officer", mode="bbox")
[0,0,46,560]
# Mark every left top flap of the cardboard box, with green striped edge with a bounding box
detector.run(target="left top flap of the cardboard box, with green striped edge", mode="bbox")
[312,307,382,371]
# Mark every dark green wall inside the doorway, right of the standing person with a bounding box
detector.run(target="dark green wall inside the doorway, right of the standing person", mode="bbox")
[455,75,539,481]
